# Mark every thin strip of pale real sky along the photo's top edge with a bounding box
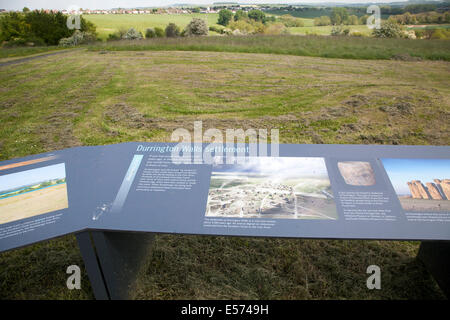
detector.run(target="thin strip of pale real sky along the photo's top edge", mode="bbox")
[0,0,406,10]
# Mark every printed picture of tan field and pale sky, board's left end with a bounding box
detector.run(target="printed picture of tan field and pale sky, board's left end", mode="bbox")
[0,163,68,224]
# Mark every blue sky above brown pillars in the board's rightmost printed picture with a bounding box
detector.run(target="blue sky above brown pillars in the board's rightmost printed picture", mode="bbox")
[381,159,450,195]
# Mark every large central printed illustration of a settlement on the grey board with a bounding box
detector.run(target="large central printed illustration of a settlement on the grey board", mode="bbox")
[205,157,338,219]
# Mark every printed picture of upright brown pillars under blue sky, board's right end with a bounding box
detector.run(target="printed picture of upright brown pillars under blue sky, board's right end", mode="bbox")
[381,159,450,212]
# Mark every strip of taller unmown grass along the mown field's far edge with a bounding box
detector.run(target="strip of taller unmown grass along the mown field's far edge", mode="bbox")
[90,35,450,61]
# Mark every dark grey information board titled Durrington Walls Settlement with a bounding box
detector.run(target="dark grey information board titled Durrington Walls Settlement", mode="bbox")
[0,142,450,251]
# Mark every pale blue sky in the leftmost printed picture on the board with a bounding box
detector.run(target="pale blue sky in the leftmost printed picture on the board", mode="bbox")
[0,163,66,193]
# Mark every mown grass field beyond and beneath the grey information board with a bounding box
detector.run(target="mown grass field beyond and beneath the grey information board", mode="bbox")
[0,48,450,299]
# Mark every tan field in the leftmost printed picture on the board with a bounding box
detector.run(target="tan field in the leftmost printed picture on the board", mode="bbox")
[0,183,69,224]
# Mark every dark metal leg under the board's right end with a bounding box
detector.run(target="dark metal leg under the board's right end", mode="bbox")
[417,241,450,298]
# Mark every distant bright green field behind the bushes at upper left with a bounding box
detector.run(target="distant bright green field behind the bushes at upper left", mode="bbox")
[83,13,219,39]
